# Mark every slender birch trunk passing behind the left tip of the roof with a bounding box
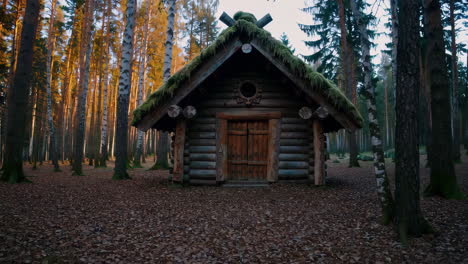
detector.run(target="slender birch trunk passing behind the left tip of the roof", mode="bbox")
[133,1,151,168]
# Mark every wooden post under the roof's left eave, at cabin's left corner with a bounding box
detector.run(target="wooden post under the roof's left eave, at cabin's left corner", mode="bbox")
[172,118,186,182]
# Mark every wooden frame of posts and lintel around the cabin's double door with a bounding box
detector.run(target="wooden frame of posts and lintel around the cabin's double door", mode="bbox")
[216,110,281,182]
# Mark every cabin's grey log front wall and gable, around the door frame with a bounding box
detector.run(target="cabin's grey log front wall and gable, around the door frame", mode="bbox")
[184,51,324,185]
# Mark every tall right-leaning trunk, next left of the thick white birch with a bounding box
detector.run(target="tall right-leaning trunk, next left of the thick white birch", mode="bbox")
[72,0,94,175]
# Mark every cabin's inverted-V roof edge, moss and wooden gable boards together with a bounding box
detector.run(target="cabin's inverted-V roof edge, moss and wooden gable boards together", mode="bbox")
[132,19,363,130]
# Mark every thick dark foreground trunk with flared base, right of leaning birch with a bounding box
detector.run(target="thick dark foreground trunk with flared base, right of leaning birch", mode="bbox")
[395,0,430,244]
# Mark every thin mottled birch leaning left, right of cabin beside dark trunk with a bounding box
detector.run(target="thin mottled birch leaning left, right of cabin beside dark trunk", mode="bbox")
[350,0,394,224]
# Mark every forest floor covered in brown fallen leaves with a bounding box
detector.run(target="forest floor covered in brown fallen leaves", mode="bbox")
[0,156,468,263]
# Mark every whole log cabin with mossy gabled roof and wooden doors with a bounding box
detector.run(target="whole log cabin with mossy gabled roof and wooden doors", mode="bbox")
[132,12,362,185]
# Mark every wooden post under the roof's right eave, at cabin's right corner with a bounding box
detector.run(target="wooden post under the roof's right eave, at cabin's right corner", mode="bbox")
[310,119,325,185]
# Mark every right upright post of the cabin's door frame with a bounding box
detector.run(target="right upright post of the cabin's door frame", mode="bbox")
[267,119,281,182]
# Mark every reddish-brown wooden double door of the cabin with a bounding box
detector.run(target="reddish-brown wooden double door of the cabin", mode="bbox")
[227,120,269,180]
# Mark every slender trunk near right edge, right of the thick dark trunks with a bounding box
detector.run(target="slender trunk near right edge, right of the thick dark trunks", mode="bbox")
[449,0,461,163]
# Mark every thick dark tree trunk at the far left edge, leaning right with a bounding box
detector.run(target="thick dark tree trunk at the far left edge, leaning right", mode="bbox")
[0,0,40,183]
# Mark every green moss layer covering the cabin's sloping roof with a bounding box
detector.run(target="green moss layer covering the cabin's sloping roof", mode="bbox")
[132,12,363,126]
